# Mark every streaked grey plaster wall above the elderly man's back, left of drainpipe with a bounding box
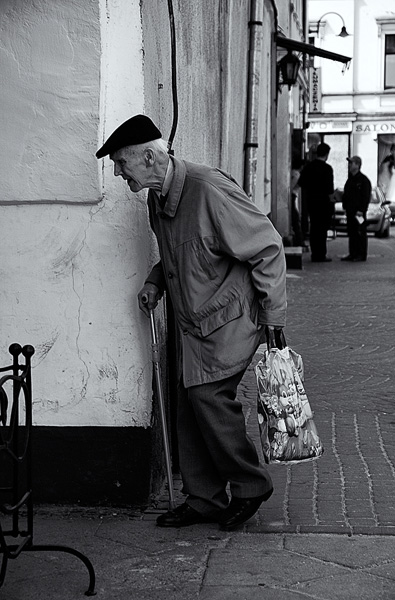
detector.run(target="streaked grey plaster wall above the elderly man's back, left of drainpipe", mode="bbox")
[142,0,251,185]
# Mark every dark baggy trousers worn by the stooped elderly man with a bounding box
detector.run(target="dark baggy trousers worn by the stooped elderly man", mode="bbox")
[177,371,273,515]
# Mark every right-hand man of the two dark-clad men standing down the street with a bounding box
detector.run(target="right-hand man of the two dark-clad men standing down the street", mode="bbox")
[341,156,372,262]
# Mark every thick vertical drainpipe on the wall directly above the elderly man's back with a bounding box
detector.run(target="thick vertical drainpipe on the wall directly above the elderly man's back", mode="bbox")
[243,0,263,200]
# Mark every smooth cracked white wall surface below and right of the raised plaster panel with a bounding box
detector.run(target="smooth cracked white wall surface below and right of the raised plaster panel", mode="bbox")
[0,0,153,427]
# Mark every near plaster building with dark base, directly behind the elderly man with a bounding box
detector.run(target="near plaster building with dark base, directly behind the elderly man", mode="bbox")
[0,0,306,505]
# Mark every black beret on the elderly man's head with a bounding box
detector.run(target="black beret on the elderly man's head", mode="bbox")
[96,115,162,158]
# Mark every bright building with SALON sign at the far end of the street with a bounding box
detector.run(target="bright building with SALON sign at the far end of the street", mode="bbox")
[308,0,395,187]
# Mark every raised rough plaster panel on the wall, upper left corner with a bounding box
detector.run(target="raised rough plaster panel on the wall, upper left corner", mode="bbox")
[0,0,100,203]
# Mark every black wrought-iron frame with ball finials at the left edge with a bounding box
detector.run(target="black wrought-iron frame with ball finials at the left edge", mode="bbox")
[0,344,95,596]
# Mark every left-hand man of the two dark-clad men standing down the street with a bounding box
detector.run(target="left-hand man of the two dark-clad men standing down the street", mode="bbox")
[299,143,334,262]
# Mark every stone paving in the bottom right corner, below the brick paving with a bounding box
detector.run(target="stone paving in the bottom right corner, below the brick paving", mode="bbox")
[199,535,395,600]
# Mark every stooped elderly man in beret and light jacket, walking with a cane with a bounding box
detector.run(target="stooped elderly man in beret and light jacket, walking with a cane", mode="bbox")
[96,115,286,530]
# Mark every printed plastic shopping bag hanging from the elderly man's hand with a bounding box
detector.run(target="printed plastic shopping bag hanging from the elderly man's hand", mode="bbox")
[255,338,324,463]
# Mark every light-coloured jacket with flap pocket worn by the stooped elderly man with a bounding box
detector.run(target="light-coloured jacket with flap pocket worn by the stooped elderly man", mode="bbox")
[146,157,286,387]
